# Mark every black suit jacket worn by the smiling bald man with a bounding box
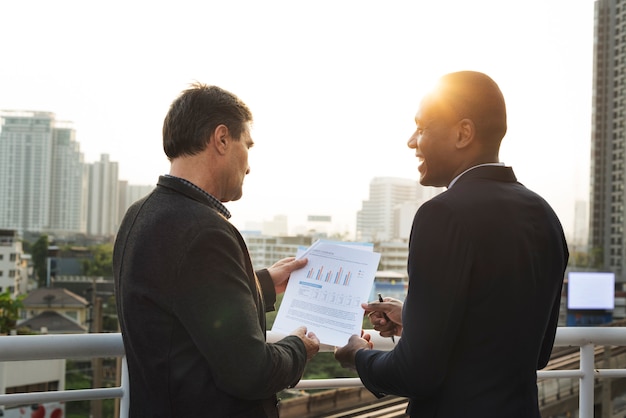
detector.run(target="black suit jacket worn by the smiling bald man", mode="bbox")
[356,166,569,418]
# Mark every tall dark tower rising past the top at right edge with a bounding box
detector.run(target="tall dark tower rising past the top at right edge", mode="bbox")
[589,0,626,283]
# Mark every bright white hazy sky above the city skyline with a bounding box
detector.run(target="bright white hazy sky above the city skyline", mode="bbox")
[0,0,594,238]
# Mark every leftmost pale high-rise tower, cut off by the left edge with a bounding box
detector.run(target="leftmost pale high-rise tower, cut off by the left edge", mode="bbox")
[0,111,54,233]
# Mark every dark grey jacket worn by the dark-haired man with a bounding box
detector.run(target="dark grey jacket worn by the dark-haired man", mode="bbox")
[113,177,306,418]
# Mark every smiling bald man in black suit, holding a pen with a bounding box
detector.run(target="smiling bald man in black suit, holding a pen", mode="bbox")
[335,71,569,418]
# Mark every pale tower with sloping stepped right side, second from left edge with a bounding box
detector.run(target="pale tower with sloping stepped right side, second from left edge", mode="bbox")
[47,121,88,235]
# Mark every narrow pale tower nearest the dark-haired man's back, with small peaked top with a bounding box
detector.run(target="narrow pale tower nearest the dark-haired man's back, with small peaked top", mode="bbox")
[87,154,119,237]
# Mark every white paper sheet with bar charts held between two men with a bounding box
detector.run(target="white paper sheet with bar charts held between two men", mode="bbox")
[272,241,380,346]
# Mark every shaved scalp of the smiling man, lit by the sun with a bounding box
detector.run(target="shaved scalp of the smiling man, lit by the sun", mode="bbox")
[427,71,506,145]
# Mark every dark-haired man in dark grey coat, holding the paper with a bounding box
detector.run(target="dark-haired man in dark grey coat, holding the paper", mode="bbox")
[113,84,319,418]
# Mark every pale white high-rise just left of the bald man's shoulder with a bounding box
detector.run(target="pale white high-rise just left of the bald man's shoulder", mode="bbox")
[356,177,441,242]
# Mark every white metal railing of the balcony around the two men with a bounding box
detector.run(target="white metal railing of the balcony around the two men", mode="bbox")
[0,327,626,418]
